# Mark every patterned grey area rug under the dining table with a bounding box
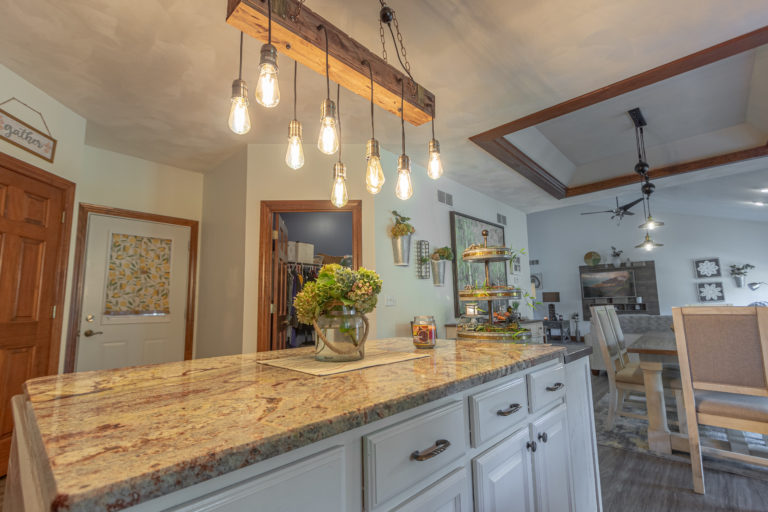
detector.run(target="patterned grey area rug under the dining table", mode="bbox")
[595,395,768,481]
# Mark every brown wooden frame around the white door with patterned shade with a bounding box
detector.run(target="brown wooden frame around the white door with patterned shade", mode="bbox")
[64,203,200,373]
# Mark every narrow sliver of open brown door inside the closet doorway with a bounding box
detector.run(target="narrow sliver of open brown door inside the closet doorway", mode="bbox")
[270,214,288,350]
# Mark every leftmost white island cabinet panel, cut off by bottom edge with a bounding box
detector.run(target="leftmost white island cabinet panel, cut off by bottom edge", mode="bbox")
[172,447,346,512]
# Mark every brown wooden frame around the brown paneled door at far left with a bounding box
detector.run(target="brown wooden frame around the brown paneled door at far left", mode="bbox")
[0,151,76,375]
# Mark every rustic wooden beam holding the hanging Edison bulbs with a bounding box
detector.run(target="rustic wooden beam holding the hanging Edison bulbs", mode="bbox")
[227,0,435,126]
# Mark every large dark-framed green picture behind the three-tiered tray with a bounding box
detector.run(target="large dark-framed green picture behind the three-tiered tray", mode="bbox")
[450,212,509,316]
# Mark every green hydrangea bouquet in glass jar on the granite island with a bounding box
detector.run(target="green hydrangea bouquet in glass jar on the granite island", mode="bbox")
[293,263,381,361]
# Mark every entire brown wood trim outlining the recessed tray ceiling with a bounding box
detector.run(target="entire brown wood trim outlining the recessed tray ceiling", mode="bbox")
[469,26,768,199]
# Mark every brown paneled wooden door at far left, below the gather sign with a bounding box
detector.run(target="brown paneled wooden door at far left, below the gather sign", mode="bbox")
[0,155,74,475]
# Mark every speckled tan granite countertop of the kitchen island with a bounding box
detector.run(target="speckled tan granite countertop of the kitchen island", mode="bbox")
[24,338,564,511]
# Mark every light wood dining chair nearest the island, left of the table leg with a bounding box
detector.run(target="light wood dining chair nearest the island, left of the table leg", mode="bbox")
[590,306,682,428]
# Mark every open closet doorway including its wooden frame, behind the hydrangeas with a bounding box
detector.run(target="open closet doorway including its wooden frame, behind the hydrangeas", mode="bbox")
[257,200,363,352]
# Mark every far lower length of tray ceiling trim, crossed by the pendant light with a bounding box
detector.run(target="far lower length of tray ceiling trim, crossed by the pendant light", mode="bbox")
[565,144,768,197]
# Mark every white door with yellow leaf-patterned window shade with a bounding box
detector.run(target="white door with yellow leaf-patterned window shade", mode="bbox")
[75,214,190,371]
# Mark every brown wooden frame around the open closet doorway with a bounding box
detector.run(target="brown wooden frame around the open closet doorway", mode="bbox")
[256,199,363,352]
